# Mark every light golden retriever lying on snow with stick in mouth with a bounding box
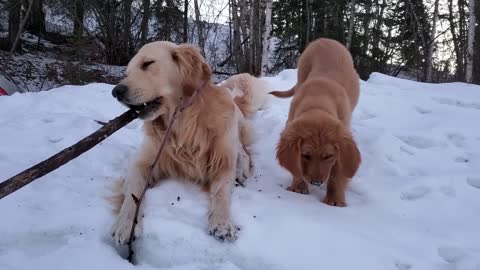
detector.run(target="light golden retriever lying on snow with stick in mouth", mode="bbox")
[112,41,266,244]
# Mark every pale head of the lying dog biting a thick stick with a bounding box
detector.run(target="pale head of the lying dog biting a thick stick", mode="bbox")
[112,41,211,120]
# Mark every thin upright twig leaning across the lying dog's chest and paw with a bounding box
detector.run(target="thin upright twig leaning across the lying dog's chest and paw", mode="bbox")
[125,80,209,263]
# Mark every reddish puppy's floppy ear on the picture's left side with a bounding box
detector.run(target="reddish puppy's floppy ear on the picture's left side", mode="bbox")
[277,125,303,178]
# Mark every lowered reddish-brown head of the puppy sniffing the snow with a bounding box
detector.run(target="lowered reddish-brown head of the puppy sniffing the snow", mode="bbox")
[277,116,361,185]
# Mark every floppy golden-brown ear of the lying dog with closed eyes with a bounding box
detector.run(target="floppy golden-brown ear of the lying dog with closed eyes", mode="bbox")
[172,44,212,96]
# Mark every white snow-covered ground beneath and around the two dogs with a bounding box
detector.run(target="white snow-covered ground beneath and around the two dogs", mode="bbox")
[0,70,480,270]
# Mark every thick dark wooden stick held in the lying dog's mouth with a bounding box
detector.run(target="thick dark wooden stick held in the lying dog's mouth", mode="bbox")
[0,110,138,199]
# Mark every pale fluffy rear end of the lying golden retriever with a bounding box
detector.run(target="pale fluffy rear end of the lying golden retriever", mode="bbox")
[221,73,269,118]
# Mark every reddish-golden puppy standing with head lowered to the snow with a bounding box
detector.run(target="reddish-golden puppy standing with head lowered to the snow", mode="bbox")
[271,38,361,207]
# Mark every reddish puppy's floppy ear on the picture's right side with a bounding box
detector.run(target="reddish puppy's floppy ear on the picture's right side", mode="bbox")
[337,133,361,178]
